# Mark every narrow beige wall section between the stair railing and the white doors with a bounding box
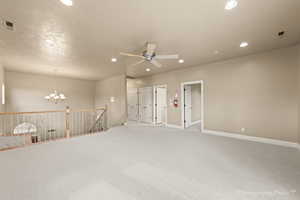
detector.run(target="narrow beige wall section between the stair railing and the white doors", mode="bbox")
[95,75,127,126]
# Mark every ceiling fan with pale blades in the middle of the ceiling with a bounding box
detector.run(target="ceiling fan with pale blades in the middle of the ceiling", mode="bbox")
[120,42,179,67]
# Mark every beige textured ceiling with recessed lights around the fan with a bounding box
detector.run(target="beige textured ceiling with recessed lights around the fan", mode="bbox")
[0,0,300,80]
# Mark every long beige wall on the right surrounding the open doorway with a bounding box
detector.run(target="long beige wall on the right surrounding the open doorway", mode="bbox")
[142,46,299,142]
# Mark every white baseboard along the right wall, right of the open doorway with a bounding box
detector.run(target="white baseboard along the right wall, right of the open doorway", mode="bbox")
[203,129,300,150]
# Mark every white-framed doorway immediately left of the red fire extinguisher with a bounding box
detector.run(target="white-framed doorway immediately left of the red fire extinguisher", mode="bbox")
[153,85,167,125]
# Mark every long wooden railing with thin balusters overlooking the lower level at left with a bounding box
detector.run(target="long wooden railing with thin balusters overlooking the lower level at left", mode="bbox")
[0,106,107,151]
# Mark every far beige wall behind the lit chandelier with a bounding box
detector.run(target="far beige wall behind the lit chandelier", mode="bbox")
[5,72,96,112]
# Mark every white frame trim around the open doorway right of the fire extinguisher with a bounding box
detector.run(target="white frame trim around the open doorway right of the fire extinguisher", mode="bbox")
[181,80,204,132]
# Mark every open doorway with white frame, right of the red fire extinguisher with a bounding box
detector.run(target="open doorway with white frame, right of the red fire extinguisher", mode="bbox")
[181,81,204,132]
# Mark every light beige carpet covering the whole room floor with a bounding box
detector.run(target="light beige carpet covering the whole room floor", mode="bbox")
[0,126,300,200]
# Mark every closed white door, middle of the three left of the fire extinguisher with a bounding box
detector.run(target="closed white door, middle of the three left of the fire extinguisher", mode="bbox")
[138,87,153,123]
